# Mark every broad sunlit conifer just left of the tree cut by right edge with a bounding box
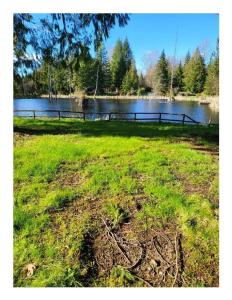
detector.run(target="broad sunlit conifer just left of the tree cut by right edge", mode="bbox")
[184,48,206,94]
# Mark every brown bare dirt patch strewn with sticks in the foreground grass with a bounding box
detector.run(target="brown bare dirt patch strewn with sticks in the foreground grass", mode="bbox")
[94,220,184,287]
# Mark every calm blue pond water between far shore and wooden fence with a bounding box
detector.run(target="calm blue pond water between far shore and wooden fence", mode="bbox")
[14,99,219,123]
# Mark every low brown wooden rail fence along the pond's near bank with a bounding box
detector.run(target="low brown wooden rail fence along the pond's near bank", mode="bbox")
[14,109,217,125]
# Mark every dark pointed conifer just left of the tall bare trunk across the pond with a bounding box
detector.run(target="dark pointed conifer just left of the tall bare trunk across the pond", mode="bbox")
[154,50,169,95]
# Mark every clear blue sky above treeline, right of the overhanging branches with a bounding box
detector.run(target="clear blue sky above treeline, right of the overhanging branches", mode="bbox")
[102,14,219,70]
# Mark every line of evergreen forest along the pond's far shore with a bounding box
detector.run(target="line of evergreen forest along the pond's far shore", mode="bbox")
[14,14,219,97]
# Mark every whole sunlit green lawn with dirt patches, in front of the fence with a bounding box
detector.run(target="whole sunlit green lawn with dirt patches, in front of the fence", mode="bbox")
[14,118,219,287]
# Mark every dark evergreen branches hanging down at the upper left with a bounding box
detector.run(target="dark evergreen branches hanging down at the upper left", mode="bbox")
[13,13,129,95]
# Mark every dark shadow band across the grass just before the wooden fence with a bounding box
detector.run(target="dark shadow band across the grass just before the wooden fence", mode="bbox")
[14,118,219,145]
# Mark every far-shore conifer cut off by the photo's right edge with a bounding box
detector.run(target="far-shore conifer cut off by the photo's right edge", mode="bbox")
[205,40,219,95]
